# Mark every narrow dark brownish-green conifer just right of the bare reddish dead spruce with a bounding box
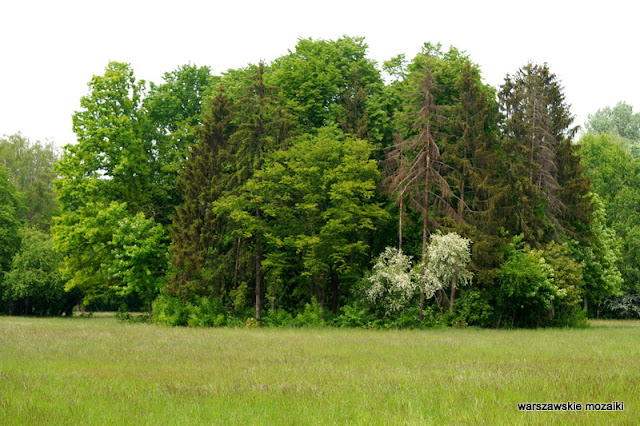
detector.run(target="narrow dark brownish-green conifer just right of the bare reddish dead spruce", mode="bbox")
[447,59,507,284]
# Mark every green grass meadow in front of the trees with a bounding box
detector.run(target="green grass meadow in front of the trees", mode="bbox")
[0,316,640,425]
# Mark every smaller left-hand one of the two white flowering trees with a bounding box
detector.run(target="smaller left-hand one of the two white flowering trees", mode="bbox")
[366,247,419,315]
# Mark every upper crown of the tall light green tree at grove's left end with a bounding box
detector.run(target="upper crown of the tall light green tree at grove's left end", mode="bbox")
[56,62,154,214]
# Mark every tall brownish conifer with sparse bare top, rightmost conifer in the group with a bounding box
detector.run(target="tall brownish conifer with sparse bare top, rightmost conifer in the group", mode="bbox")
[499,64,576,245]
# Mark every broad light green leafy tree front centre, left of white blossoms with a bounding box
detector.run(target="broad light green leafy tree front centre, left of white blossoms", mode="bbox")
[215,128,387,311]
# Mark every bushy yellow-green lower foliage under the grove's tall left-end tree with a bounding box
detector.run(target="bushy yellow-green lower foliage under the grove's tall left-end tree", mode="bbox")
[53,202,167,318]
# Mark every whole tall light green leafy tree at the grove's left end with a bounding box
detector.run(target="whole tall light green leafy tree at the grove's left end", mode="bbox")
[52,62,172,310]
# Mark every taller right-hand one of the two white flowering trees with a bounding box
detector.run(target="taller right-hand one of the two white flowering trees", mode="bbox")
[420,232,473,312]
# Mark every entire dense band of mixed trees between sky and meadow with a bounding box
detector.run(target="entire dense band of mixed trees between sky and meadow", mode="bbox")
[0,36,640,327]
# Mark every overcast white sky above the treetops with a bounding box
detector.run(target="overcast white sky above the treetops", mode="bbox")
[0,0,640,146]
